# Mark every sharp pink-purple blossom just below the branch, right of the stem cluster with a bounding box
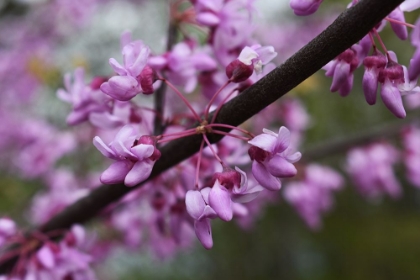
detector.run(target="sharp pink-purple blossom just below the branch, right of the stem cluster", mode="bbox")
[248,126,302,191]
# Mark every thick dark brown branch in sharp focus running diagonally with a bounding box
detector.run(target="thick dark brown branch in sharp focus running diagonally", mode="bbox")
[0,0,403,274]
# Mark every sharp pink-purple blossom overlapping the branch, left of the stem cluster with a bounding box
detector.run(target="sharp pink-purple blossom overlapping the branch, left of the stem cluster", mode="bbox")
[93,125,160,187]
